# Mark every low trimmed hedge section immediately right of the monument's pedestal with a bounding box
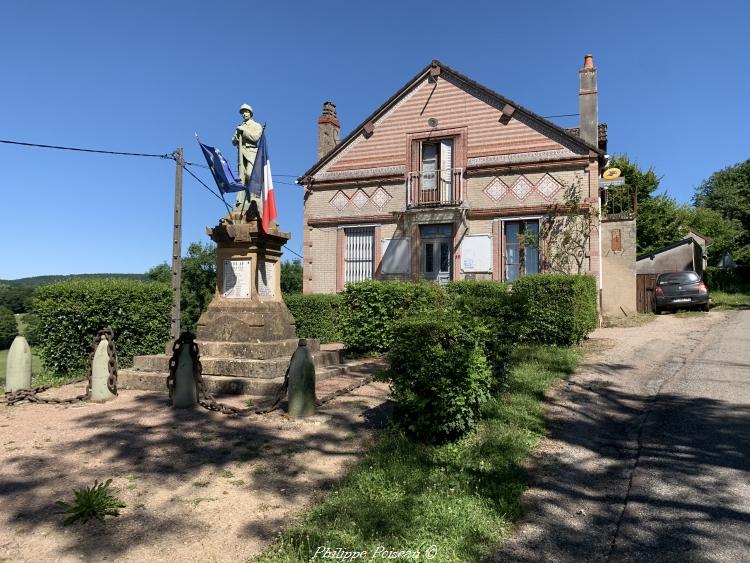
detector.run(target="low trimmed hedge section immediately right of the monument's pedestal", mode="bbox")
[284,294,342,342]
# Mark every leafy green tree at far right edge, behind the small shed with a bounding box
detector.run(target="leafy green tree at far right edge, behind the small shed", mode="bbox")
[694,159,750,264]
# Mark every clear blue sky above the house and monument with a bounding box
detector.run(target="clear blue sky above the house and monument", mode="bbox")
[0,0,750,279]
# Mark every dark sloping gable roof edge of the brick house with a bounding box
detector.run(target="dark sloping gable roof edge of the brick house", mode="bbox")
[298,59,606,183]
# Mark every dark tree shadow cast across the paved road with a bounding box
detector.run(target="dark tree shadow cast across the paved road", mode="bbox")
[493,378,750,562]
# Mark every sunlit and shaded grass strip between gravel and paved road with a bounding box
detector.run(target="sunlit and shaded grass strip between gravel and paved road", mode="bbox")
[259,347,580,562]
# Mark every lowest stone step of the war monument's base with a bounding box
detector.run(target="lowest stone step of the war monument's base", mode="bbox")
[117,360,373,401]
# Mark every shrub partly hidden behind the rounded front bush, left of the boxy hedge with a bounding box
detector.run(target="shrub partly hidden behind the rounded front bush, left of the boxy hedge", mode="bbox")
[446,281,527,386]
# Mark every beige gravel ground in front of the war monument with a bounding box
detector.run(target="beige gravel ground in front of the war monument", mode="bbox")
[0,377,388,562]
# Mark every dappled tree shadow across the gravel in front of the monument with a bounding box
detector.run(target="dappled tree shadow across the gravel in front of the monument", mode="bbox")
[0,388,390,560]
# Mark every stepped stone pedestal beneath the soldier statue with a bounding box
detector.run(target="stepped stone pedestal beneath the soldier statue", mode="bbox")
[118,215,345,399]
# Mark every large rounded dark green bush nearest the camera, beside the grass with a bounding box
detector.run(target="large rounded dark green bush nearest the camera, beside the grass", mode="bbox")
[389,310,492,443]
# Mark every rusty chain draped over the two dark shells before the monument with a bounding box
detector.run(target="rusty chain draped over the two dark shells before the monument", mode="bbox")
[167,332,373,417]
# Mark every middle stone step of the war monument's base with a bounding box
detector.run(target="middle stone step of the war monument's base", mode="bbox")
[133,350,342,379]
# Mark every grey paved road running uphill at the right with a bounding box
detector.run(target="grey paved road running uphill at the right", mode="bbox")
[496,310,750,562]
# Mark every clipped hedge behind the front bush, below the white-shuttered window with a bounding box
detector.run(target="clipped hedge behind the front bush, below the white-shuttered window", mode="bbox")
[341,280,447,352]
